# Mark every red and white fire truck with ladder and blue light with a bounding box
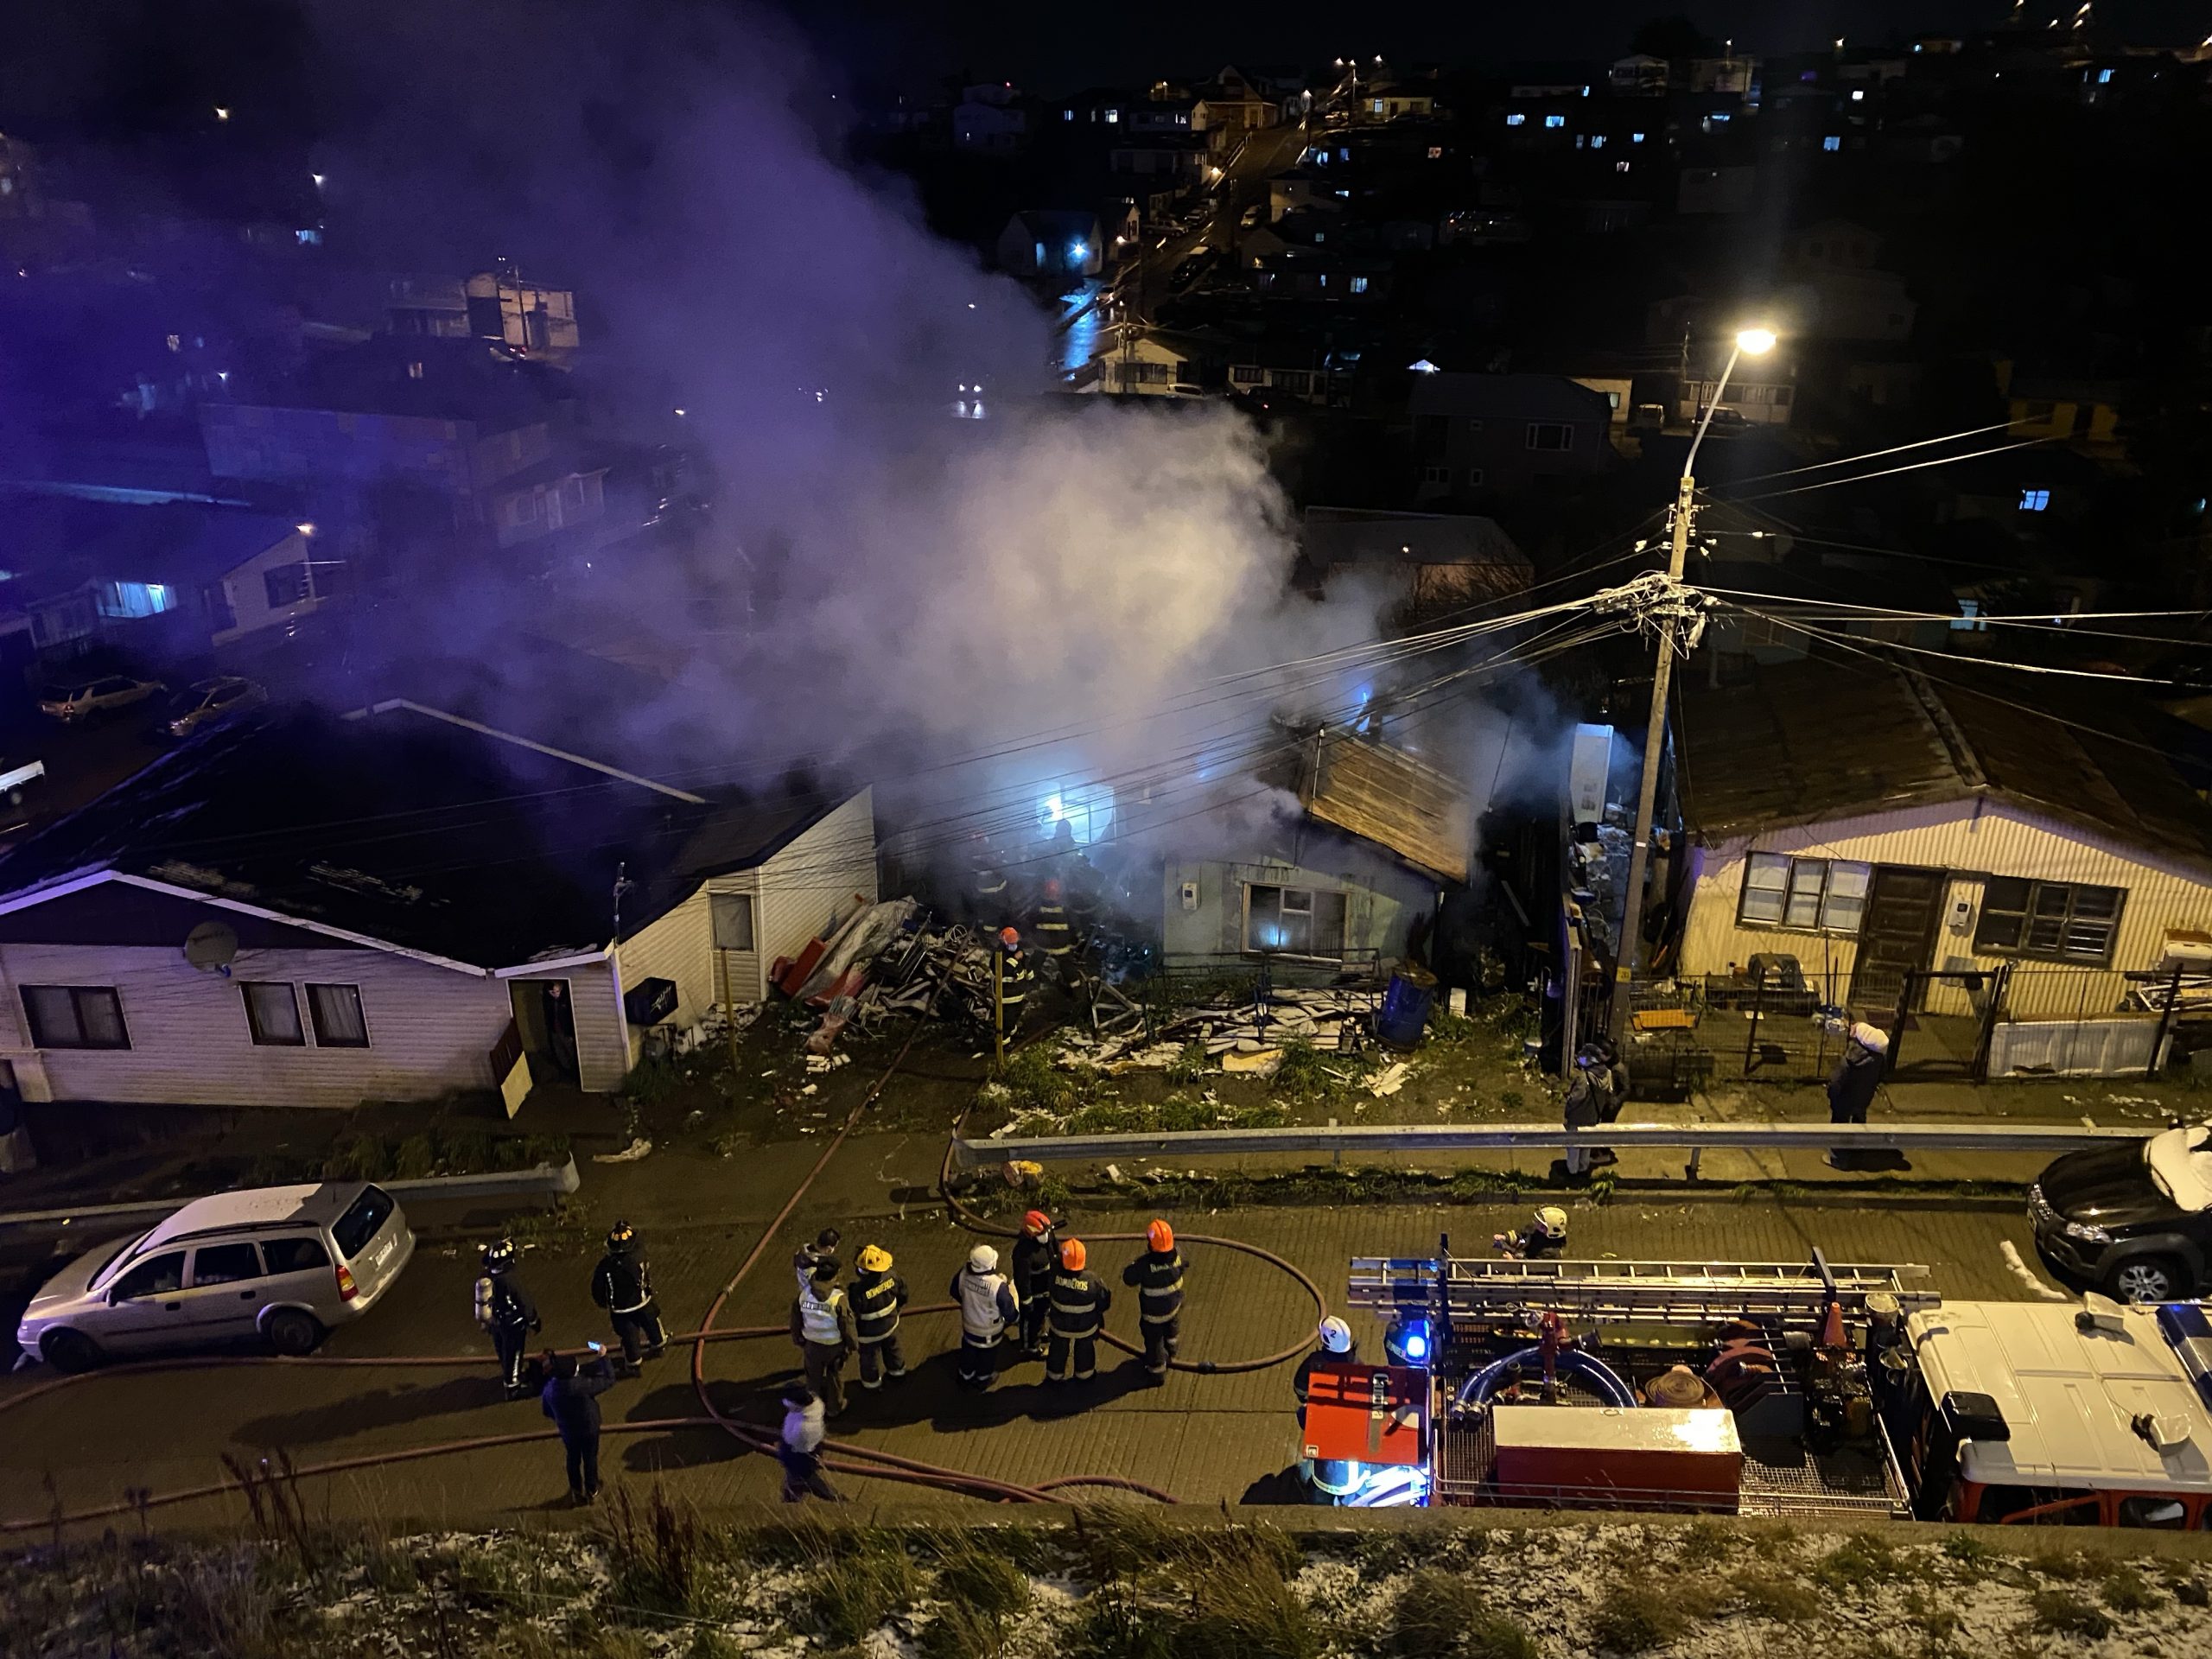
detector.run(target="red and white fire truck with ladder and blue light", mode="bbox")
[1300,1236,2212,1531]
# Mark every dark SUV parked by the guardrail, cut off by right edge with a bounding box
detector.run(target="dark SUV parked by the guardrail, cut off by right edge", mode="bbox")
[2029,1123,2212,1303]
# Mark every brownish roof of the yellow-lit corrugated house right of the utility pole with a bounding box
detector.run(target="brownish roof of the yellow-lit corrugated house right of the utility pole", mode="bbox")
[1676,657,2212,872]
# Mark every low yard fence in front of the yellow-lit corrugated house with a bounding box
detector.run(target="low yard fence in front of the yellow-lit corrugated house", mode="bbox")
[1626,963,2185,1095]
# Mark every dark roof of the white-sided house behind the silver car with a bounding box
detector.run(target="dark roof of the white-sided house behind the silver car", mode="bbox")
[0,706,838,969]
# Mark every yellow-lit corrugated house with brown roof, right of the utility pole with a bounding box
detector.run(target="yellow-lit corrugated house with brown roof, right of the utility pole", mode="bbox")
[1676,659,2212,1052]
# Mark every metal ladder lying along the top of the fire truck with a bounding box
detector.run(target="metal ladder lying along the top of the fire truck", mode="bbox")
[1347,1239,1942,1323]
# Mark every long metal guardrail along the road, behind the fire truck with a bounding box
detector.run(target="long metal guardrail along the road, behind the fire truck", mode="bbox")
[953,1123,2144,1174]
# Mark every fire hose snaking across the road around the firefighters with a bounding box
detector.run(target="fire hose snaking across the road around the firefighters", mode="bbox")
[0,1020,1300,1535]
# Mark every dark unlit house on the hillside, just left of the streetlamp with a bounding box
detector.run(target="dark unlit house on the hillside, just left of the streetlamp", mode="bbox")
[1411,374,1612,500]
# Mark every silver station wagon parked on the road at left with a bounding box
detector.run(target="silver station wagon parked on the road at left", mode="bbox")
[16,1181,414,1371]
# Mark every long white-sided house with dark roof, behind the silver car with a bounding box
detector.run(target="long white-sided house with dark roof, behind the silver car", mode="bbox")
[0,703,876,1109]
